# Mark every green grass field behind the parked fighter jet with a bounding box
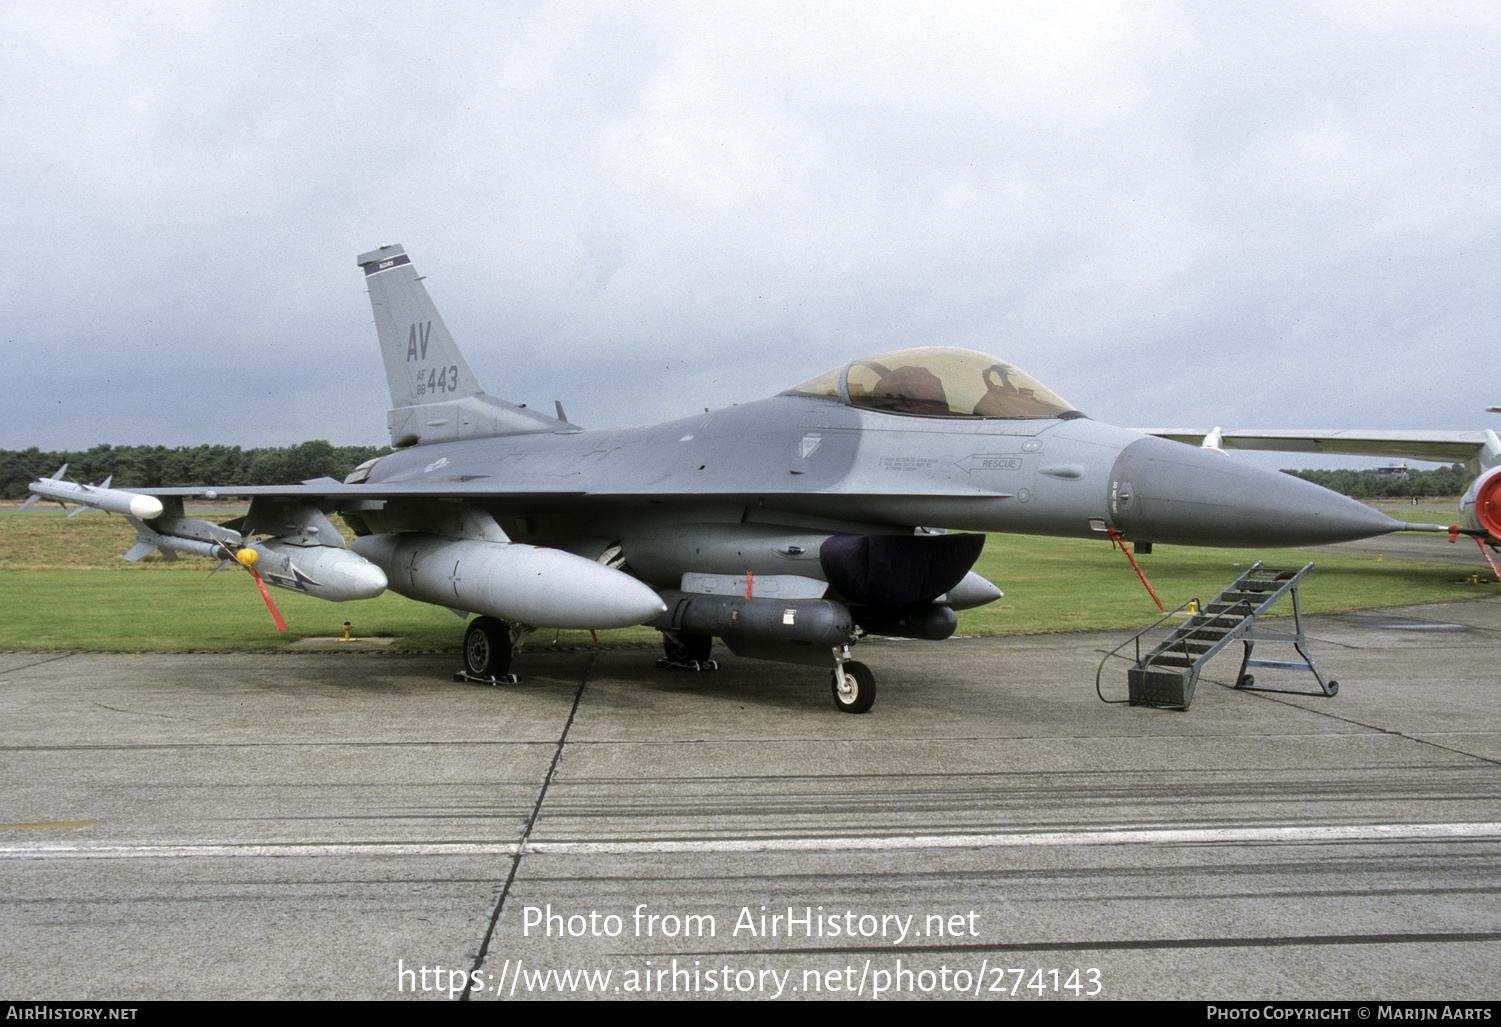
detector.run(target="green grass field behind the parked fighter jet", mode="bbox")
[0,506,1501,650]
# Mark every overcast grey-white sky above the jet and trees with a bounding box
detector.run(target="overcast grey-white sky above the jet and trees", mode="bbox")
[0,0,1501,465]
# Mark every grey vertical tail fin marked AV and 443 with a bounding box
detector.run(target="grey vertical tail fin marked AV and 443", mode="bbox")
[359,246,578,446]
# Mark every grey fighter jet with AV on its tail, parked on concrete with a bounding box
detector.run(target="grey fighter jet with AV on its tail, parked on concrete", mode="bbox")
[32,246,1403,713]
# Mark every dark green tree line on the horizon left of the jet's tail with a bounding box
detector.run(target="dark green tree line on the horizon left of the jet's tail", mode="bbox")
[0,438,390,500]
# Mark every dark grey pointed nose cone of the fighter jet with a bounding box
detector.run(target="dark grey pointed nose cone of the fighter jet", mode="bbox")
[1108,438,1405,547]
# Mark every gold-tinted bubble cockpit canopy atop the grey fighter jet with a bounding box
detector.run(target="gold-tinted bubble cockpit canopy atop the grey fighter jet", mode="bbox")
[785,345,1084,419]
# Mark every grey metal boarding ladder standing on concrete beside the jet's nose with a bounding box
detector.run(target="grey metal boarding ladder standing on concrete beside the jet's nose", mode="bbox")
[1094,563,1339,710]
